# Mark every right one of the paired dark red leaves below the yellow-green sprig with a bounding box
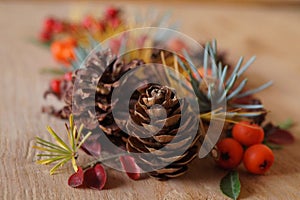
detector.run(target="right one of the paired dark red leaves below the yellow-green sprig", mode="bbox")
[84,164,107,190]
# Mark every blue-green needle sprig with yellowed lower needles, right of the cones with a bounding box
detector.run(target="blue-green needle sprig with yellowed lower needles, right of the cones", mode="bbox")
[161,40,272,119]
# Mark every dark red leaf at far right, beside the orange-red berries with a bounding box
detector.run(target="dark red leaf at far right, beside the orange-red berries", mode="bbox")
[268,128,295,145]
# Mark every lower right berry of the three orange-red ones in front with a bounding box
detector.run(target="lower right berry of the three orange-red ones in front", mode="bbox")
[243,144,274,174]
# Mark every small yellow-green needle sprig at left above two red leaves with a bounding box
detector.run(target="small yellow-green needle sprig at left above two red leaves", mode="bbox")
[33,114,92,175]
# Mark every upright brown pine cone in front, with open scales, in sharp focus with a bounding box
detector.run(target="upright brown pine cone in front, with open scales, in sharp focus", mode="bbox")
[126,84,200,180]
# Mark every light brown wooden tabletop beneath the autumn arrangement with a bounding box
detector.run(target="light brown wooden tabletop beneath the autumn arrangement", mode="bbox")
[0,1,300,200]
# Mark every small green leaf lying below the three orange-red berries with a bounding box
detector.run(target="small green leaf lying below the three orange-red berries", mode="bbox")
[220,171,241,200]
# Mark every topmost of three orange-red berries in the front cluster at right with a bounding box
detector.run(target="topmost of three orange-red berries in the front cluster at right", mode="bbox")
[232,121,265,146]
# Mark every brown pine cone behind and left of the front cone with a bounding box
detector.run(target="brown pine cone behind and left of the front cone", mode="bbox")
[72,50,144,146]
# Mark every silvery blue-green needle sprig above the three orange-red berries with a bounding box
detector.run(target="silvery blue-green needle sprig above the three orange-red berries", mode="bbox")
[168,40,272,118]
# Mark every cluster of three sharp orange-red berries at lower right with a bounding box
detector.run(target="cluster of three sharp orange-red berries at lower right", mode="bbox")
[217,121,274,174]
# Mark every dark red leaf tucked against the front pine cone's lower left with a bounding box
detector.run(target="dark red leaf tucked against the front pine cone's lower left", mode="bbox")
[120,156,141,180]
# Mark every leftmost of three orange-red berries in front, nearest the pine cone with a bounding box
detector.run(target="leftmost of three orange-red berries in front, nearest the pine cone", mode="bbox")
[217,138,244,169]
